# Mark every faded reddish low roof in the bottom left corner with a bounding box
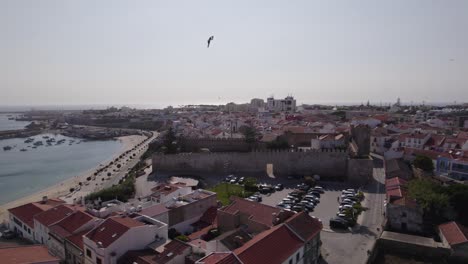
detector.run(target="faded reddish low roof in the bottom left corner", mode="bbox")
[0,245,60,264]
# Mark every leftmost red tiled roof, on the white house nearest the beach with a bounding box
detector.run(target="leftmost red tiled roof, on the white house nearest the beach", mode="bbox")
[8,199,64,228]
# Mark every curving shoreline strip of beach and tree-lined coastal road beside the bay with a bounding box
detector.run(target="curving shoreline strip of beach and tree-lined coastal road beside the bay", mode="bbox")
[0,132,158,223]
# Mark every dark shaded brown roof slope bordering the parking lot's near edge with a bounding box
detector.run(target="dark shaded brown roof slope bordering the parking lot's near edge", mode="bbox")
[285,212,323,241]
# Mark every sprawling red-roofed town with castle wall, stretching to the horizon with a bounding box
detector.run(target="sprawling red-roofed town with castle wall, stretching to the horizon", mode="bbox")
[0,95,468,264]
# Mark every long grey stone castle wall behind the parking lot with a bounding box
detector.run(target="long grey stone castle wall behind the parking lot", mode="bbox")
[153,150,349,179]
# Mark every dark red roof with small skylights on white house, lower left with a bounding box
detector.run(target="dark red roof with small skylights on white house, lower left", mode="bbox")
[85,216,144,248]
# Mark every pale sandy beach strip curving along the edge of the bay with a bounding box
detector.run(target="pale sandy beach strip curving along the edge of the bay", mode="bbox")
[0,135,146,223]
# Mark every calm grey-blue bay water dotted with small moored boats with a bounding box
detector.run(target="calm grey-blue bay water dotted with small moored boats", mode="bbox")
[0,115,122,204]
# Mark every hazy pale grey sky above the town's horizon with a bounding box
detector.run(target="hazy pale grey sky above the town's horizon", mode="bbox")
[0,0,468,105]
